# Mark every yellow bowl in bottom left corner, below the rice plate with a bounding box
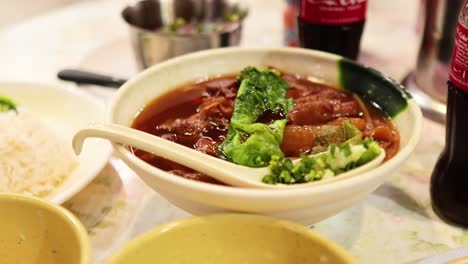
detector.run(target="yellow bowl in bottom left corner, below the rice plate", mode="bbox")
[0,193,91,264]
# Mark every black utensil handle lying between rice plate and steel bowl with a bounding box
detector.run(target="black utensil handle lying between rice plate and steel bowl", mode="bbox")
[57,69,127,88]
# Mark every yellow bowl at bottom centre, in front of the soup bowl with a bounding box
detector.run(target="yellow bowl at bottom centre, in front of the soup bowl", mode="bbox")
[107,214,356,264]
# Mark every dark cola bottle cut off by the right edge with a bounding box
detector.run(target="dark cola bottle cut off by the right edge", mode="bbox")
[431,0,468,228]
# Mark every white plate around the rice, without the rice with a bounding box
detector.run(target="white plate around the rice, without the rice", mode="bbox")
[0,82,112,204]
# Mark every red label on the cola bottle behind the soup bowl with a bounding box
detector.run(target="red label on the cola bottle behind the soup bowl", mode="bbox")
[299,0,367,25]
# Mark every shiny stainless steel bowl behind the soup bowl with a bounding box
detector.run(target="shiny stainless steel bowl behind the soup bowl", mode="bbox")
[122,0,246,68]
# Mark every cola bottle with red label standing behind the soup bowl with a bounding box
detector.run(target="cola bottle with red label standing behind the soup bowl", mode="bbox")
[297,0,367,60]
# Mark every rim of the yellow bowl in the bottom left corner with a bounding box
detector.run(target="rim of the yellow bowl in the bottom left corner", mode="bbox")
[0,193,91,264]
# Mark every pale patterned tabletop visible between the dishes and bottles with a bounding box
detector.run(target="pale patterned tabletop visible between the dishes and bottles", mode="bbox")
[0,0,468,264]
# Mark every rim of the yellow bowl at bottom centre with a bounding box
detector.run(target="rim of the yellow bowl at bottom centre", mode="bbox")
[105,213,356,264]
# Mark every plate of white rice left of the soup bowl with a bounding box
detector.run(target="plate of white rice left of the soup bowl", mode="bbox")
[0,82,112,204]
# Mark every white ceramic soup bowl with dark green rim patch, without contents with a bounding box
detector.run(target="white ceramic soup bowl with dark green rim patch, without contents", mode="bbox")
[108,48,422,224]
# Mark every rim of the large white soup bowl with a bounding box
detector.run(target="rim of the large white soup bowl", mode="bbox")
[107,47,423,199]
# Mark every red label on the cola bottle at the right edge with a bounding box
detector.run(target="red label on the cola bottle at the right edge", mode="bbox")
[450,23,468,92]
